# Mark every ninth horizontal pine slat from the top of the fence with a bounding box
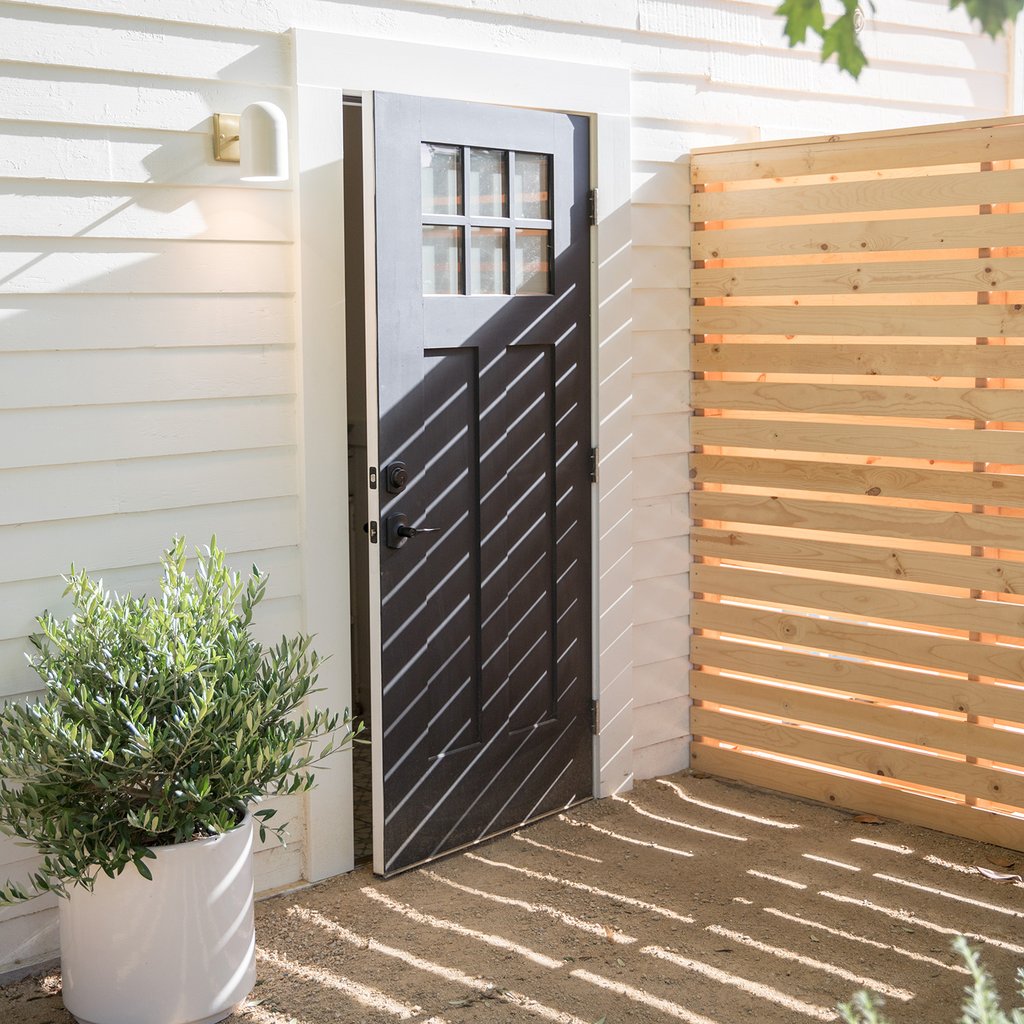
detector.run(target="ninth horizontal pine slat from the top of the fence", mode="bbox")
[690,454,1024,508]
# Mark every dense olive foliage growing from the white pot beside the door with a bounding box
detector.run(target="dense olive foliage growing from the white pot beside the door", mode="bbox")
[0,539,362,904]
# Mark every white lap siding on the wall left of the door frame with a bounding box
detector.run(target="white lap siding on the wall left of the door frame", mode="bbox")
[0,4,304,968]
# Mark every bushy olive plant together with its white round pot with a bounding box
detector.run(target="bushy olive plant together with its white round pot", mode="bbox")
[0,539,358,1024]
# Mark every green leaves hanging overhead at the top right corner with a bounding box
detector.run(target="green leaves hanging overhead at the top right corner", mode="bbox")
[775,0,1024,78]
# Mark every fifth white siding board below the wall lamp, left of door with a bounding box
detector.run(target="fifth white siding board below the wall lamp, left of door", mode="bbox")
[0,395,296,469]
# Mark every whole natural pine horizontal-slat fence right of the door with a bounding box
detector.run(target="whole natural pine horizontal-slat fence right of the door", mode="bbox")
[690,118,1024,850]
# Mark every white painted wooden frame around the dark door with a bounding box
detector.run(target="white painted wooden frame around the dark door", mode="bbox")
[292,29,633,881]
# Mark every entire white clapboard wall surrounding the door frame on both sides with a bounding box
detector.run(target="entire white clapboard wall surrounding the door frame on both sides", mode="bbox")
[0,0,1022,967]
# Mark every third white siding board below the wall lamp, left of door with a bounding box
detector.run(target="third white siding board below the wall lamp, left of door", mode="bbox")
[0,293,294,352]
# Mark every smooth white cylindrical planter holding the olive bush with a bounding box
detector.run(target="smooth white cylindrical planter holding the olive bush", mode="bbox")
[57,815,256,1024]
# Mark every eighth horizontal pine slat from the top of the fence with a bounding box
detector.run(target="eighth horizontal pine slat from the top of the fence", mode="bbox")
[690,417,1024,464]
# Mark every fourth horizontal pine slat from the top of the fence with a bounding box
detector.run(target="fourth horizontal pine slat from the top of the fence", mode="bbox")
[690,258,1024,298]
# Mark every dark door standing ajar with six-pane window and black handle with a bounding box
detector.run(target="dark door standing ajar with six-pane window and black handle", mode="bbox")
[374,93,592,873]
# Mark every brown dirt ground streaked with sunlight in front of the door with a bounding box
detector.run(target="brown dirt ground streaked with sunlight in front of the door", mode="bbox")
[0,775,1024,1024]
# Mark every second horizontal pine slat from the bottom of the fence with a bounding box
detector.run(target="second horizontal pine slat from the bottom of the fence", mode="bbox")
[691,708,1024,804]
